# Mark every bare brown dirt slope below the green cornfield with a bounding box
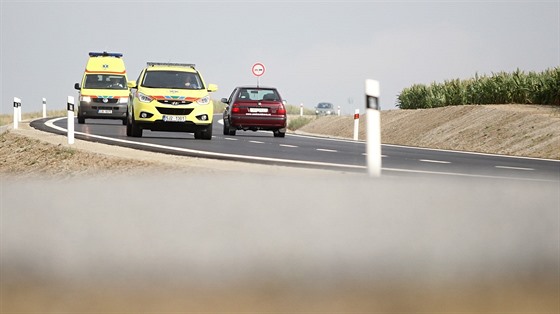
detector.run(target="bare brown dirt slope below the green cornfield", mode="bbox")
[300,105,560,159]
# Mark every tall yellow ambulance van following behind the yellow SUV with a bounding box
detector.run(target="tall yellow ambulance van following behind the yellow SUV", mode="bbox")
[74,52,130,125]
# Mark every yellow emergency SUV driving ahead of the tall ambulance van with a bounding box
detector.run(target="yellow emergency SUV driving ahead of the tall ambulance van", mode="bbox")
[126,62,218,140]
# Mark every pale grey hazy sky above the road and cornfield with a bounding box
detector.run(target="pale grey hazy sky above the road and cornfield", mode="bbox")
[0,0,560,113]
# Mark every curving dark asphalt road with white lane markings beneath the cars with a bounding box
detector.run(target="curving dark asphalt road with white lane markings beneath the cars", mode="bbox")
[31,115,560,181]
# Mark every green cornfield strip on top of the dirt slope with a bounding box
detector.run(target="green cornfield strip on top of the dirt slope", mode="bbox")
[397,67,560,109]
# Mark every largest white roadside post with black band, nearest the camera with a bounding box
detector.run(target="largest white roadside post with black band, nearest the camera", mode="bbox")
[366,79,381,177]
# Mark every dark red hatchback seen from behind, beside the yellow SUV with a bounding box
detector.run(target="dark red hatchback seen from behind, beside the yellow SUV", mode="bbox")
[222,87,287,137]
